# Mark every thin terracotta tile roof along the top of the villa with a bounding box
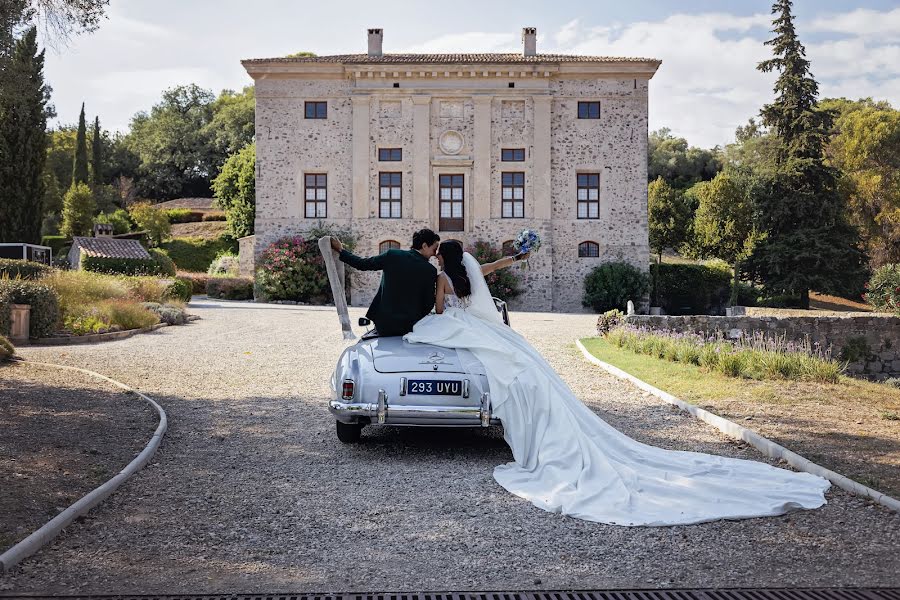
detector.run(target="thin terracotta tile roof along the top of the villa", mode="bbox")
[242,53,660,65]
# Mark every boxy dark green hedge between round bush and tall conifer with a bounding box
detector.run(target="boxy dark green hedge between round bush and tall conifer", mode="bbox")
[653,262,731,315]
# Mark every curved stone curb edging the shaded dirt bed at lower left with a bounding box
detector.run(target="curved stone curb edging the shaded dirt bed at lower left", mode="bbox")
[0,361,168,573]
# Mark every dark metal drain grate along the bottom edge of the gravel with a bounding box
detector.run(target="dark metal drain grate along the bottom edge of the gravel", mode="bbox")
[0,588,900,600]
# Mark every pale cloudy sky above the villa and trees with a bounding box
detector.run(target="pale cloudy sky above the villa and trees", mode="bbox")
[38,0,900,147]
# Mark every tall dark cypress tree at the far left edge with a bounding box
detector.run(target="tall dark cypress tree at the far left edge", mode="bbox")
[0,27,52,243]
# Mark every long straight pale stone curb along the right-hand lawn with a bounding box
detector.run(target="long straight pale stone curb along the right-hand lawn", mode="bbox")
[575,340,900,512]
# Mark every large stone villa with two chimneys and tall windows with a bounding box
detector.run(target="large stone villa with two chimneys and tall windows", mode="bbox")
[242,28,660,311]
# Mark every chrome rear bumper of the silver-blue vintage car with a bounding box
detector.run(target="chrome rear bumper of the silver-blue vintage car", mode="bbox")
[328,391,500,427]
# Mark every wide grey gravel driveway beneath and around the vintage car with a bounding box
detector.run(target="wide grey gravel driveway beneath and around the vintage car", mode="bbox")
[0,300,900,594]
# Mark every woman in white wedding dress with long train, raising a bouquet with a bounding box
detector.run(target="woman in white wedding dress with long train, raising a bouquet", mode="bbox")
[404,241,829,525]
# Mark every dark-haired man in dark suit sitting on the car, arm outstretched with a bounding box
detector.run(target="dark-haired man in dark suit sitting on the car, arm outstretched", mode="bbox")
[331,229,441,336]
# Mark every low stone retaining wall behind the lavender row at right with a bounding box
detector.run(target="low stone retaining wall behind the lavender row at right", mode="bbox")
[627,315,900,380]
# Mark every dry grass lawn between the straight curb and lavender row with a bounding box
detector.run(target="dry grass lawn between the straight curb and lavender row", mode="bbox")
[581,338,900,497]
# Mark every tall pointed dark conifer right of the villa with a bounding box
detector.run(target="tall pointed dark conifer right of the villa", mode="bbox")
[747,0,866,308]
